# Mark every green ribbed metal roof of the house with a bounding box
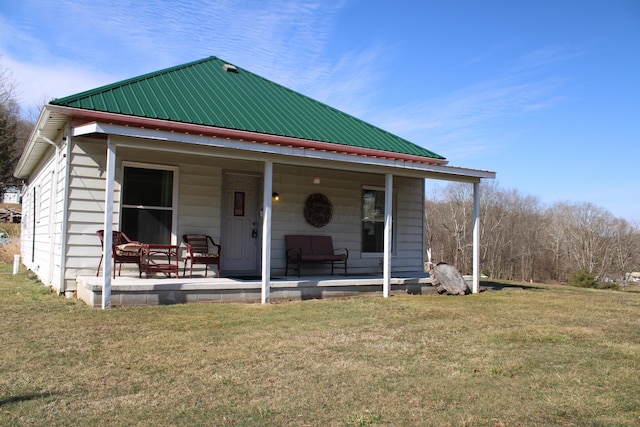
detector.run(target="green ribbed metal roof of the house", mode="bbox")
[51,56,444,159]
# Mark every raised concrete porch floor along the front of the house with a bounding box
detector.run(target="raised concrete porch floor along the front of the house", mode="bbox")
[76,272,434,308]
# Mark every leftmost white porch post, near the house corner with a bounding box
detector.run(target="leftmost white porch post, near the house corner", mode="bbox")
[102,136,116,310]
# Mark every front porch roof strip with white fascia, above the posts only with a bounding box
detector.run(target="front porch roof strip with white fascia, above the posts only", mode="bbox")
[74,115,495,182]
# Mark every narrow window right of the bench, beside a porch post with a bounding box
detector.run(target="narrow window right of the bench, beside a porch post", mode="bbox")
[362,188,392,253]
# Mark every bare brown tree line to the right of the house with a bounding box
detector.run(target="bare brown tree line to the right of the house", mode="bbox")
[425,182,640,283]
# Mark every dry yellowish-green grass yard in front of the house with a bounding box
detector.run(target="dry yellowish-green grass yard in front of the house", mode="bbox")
[0,264,640,427]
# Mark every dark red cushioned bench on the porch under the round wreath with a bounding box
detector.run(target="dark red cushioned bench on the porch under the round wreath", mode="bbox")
[284,235,349,277]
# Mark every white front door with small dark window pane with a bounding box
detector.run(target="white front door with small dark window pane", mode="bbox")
[221,172,260,274]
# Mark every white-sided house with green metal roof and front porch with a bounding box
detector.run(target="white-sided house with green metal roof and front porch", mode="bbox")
[14,57,495,308]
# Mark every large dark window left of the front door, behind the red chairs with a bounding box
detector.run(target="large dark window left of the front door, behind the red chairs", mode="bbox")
[120,166,175,243]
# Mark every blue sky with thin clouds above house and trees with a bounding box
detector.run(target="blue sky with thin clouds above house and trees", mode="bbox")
[0,0,640,224]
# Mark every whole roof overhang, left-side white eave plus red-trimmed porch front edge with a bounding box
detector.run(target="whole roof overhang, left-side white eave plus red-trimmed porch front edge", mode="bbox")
[15,104,495,182]
